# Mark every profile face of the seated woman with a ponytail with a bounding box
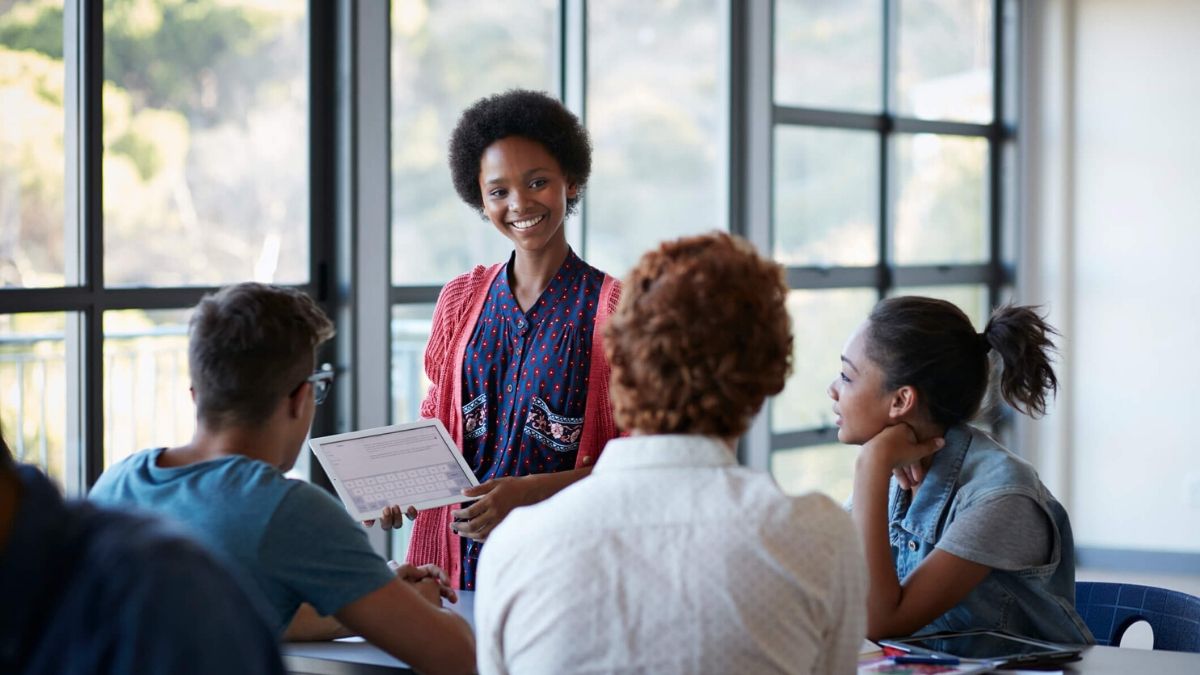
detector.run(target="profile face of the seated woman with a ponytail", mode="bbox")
[829,322,892,446]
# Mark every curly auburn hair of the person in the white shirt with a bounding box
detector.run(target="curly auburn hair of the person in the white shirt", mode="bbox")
[605,232,792,438]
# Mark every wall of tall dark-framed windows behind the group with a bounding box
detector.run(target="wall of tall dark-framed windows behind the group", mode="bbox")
[0,0,1019,516]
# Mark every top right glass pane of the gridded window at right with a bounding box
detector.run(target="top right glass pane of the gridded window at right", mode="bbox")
[895,0,995,123]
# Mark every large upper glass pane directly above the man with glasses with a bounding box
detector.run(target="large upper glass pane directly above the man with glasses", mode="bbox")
[103,0,308,286]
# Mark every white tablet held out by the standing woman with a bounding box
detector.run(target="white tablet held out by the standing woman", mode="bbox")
[308,419,479,520]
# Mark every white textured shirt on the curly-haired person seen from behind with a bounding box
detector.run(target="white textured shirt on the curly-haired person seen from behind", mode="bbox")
[475,436,866,675]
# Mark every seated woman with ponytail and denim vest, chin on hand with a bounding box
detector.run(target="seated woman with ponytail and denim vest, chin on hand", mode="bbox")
[829,297,1093,644]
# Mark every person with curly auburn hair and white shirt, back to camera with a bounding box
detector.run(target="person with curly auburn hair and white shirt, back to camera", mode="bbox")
[475,233,866,674]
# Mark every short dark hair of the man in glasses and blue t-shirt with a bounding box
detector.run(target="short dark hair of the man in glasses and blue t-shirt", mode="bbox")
[187,283,334,429]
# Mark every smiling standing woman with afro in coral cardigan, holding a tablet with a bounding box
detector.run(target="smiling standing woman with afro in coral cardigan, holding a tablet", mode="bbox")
[372,90,620,590]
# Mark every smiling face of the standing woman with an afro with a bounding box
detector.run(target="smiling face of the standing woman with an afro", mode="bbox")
[479,136,578,252]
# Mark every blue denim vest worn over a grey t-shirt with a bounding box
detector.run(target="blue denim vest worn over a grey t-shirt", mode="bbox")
[888,425,1096,644]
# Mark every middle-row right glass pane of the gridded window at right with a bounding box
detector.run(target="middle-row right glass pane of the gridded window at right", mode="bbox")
[893,133,989,264]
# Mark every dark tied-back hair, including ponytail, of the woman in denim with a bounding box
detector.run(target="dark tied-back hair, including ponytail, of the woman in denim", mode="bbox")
[866,295,1058,426]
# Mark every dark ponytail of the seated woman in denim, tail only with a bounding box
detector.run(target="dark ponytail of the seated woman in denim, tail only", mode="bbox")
[983,305,1058,417]
